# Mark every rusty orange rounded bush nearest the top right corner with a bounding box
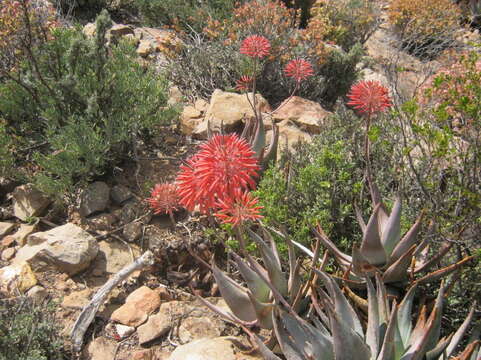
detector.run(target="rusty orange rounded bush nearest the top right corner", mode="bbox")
[388,0,461,58]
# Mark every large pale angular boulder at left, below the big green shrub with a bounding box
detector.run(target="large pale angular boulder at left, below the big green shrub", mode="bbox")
[14,223,99,275]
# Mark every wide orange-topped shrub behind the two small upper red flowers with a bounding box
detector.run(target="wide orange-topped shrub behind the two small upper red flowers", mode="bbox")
[168,0,362,106]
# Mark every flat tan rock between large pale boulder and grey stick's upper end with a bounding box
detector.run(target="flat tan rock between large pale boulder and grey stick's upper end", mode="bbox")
[92,241,140,274]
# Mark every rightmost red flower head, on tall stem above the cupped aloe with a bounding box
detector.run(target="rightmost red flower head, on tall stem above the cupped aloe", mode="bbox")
[347,81,392,116]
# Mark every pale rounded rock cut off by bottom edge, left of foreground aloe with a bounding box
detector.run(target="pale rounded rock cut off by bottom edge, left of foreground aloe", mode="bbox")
[169,337,247,360]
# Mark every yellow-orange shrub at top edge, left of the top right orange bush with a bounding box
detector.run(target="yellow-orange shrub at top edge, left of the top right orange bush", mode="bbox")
[308,0,380,50]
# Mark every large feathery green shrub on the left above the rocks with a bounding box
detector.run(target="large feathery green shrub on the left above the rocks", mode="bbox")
[0,9,174,198]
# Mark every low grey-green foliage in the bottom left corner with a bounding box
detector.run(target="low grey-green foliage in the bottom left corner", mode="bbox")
[0,299,69,360]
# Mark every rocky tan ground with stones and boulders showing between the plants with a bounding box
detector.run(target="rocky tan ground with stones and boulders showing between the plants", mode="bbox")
[0,9,478,360]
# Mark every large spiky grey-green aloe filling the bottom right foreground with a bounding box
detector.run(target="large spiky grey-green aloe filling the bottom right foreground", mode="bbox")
[251,270,481,360]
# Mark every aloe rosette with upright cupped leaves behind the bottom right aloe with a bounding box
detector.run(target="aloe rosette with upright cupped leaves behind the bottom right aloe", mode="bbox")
[293,184,473,287]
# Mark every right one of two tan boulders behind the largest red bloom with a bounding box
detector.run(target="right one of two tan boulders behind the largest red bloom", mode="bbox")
[274,96,331,134]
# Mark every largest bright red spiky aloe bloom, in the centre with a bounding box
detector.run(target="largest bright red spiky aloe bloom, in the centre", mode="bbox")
[177,134,260,212]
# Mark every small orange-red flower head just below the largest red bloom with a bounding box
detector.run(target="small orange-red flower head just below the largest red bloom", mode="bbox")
[214,189,262,226]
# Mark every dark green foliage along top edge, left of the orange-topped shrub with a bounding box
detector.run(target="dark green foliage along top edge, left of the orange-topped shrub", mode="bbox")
[134,0,242,32]
